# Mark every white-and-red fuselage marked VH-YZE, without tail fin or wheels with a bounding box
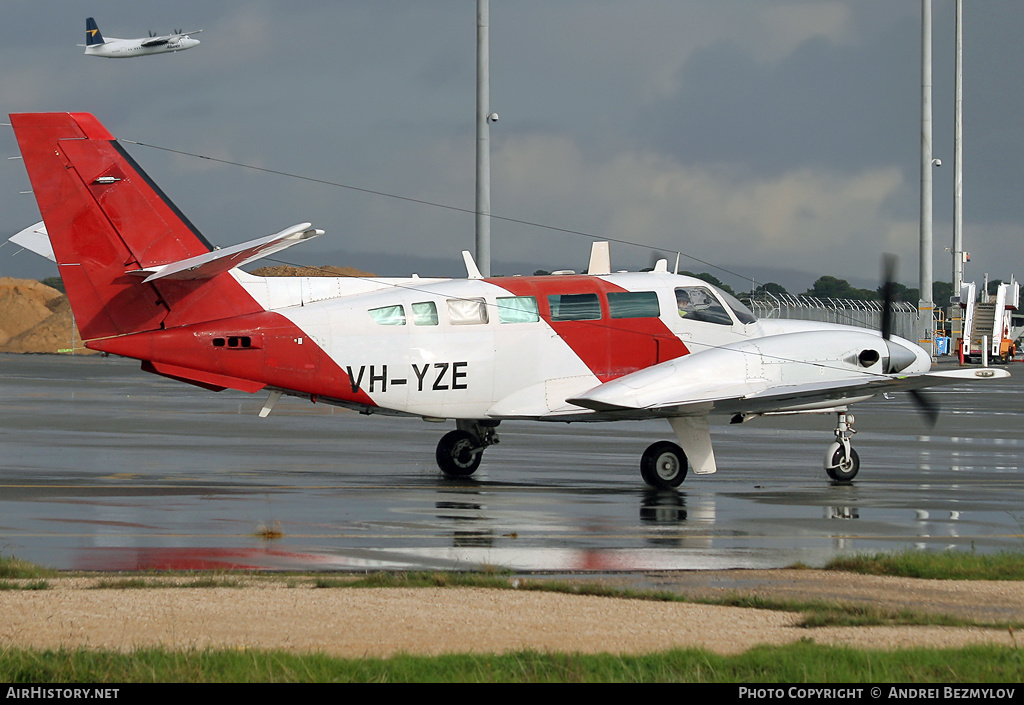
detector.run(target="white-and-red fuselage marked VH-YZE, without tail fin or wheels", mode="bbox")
[90,272,929,421]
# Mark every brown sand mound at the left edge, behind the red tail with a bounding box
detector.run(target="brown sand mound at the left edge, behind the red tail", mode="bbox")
[0,277,91,354]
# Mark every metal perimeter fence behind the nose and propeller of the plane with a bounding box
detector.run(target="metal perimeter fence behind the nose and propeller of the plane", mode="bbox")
[743,293,918,340]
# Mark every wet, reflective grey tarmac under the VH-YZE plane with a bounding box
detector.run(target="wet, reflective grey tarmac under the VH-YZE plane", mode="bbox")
[0,355,1024,573]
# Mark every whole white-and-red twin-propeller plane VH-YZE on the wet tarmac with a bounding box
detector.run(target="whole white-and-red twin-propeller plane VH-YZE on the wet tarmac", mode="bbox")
[10,113,1009,488]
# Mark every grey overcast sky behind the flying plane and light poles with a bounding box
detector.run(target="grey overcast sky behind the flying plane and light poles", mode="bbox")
[0,0,1024,292]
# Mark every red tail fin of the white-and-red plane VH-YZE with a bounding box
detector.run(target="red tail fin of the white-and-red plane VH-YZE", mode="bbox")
[10,113,262,343]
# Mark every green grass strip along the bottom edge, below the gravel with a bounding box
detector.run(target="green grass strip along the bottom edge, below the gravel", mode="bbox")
[0,641,1024,685]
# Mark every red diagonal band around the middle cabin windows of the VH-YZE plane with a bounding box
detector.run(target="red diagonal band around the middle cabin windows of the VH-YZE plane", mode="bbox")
[487,275,689,382]
